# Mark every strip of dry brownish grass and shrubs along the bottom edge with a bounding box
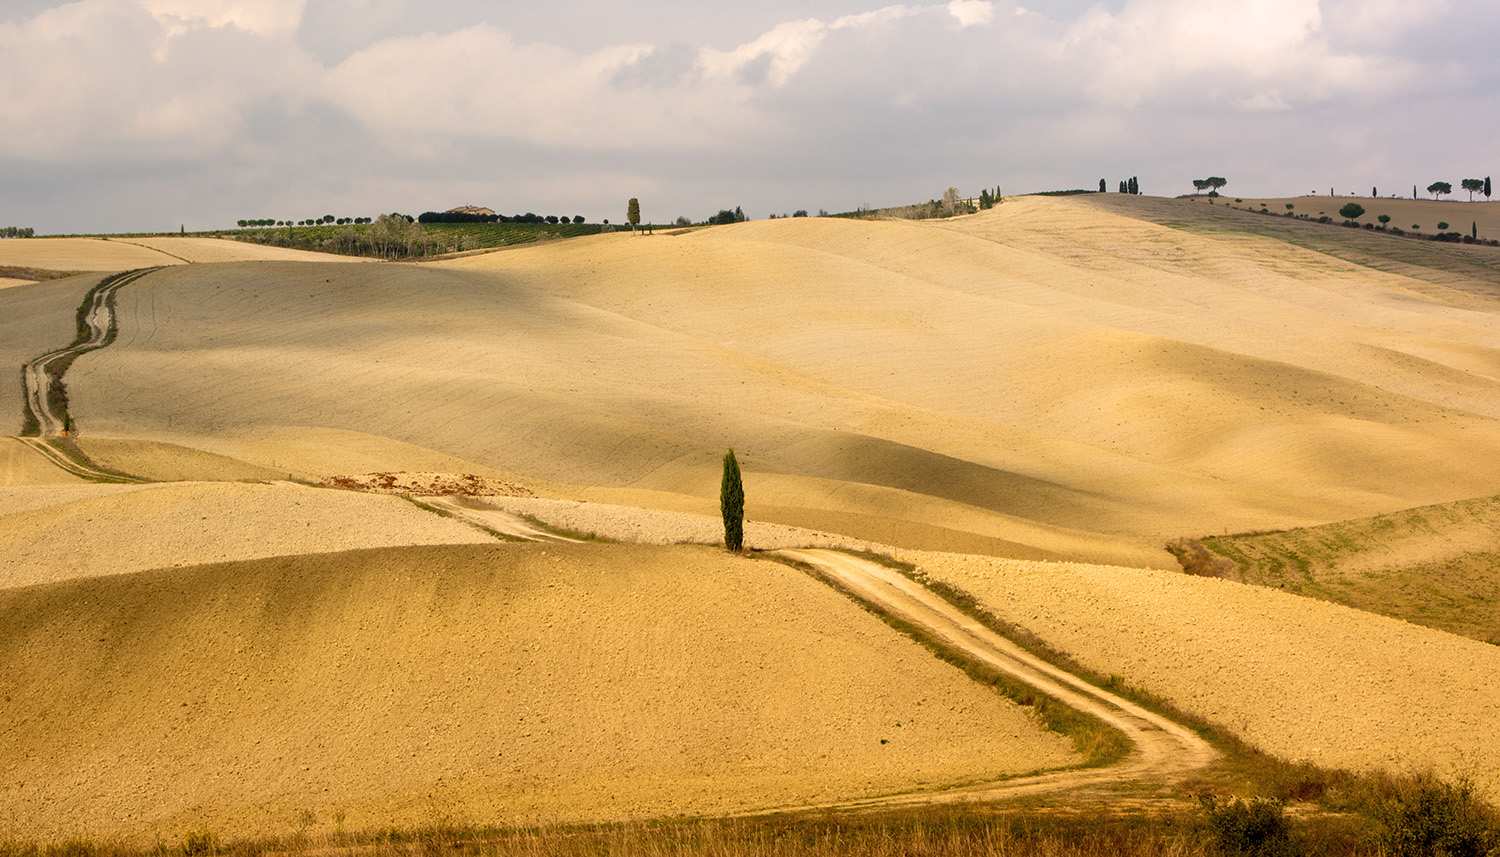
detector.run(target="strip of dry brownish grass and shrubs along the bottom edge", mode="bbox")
[0,771,1500,857]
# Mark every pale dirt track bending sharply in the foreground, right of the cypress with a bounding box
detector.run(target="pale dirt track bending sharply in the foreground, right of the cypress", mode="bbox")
[780,549,1218,809]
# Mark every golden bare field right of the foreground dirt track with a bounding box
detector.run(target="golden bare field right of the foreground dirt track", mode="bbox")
[906,554,1500,800]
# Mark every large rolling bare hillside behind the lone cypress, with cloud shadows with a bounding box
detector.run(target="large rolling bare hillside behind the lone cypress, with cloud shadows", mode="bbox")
[46,198,1500,567]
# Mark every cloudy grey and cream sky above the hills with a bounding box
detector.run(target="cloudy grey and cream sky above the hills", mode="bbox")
[0,0,1500,234]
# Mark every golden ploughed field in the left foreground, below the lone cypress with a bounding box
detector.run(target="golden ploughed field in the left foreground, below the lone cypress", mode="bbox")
[0,546,1074,842]
